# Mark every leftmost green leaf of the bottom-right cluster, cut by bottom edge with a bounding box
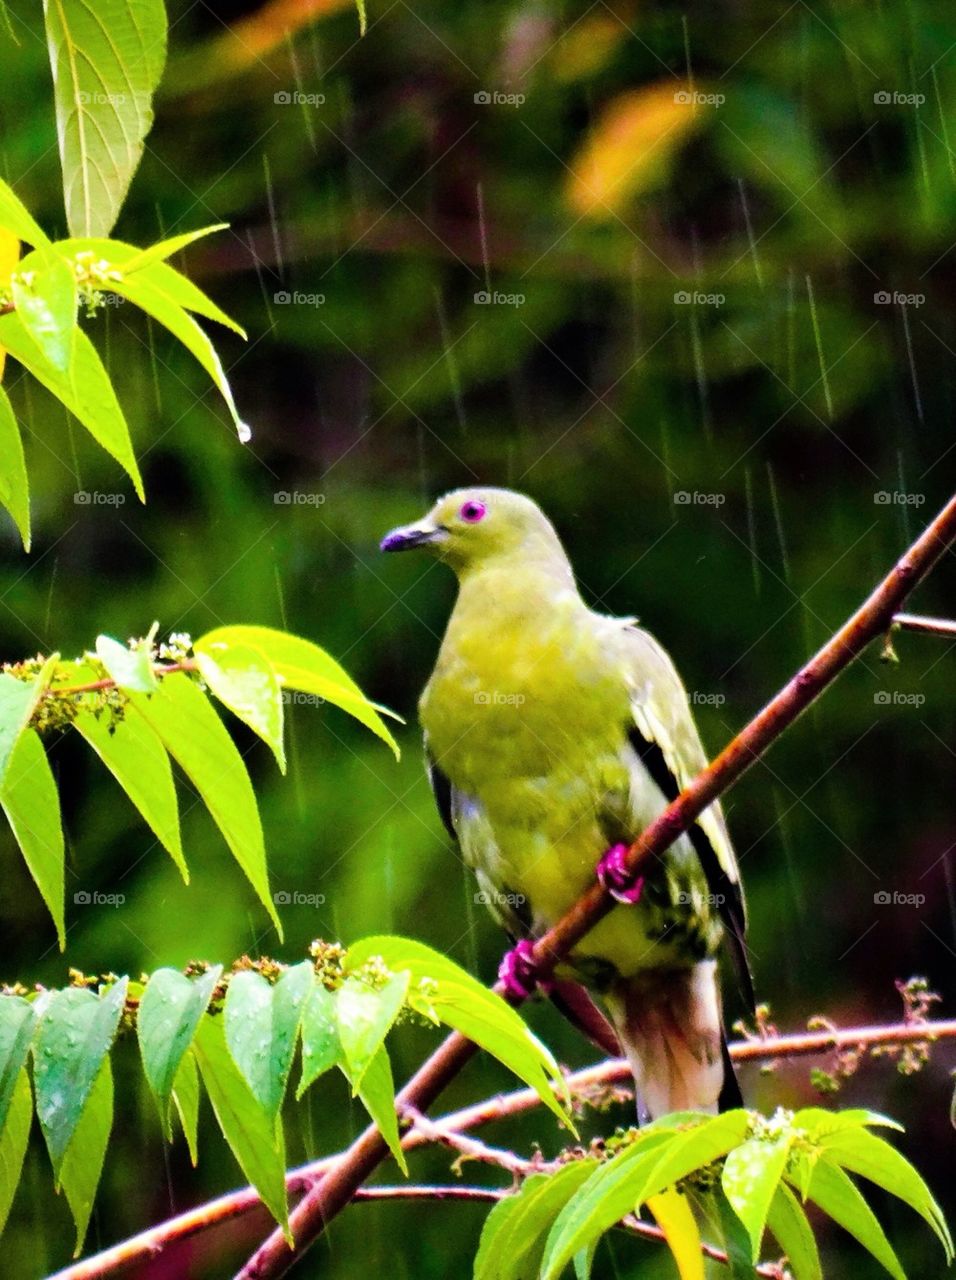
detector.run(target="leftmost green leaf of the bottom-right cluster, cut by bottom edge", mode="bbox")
[475,1160,596,1280]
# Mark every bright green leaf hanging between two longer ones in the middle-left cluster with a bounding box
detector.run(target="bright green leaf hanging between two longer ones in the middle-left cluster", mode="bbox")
[73,712,189,884]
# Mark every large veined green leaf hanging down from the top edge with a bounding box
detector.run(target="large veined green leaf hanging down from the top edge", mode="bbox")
[44,0,166,236]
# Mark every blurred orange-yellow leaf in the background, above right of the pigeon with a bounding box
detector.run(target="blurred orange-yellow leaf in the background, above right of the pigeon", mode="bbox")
[567,79,713,218]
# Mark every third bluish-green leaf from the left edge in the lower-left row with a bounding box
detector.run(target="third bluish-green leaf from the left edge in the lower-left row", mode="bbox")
[136,965,223,1138]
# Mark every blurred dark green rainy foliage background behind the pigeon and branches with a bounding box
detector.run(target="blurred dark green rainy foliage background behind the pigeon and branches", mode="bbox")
[0,0,956,1280]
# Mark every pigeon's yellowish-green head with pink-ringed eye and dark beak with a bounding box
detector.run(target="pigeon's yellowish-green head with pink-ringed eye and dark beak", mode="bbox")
[381,488,567,575]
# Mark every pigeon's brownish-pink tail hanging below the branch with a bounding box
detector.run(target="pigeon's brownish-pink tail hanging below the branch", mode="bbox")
[605,960,729,1119]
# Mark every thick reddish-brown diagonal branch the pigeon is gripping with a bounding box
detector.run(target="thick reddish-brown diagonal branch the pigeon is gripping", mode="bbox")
[237,497,956,1280]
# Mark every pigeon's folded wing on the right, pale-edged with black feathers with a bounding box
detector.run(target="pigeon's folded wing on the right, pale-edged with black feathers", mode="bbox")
[625,626,755,1009]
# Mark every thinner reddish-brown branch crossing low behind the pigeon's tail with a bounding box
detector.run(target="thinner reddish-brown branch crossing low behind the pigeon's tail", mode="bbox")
[51,1019,956,1280]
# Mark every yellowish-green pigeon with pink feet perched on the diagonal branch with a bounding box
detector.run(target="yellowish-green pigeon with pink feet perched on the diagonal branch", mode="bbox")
[381,488,753,1117]
